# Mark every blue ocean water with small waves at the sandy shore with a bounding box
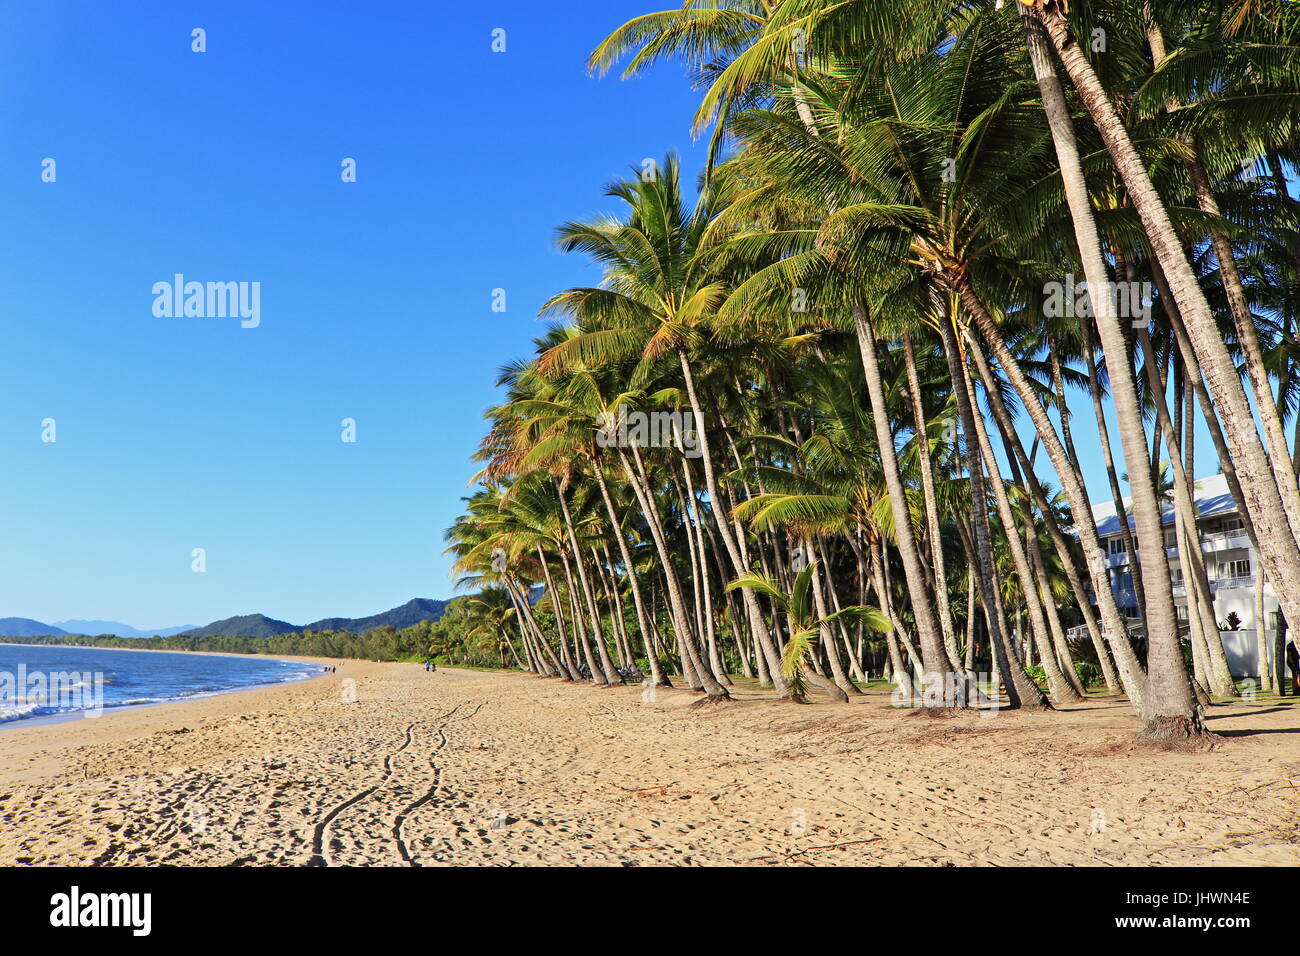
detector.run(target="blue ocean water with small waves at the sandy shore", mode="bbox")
[0,644,324,727]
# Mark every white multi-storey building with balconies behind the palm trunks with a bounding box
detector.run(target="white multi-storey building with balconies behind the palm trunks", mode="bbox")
[1092,475,1278,676]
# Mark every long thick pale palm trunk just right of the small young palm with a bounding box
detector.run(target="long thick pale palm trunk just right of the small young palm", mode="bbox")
[853,302,965,706]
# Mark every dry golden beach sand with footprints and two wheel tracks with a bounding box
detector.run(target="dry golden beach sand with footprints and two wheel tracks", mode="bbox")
[0,662,1300,866]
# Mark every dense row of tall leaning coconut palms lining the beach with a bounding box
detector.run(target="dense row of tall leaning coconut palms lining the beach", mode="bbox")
[449,0,1300,740]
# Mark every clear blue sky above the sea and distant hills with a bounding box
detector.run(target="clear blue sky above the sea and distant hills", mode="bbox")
[0,0,1206,627]
